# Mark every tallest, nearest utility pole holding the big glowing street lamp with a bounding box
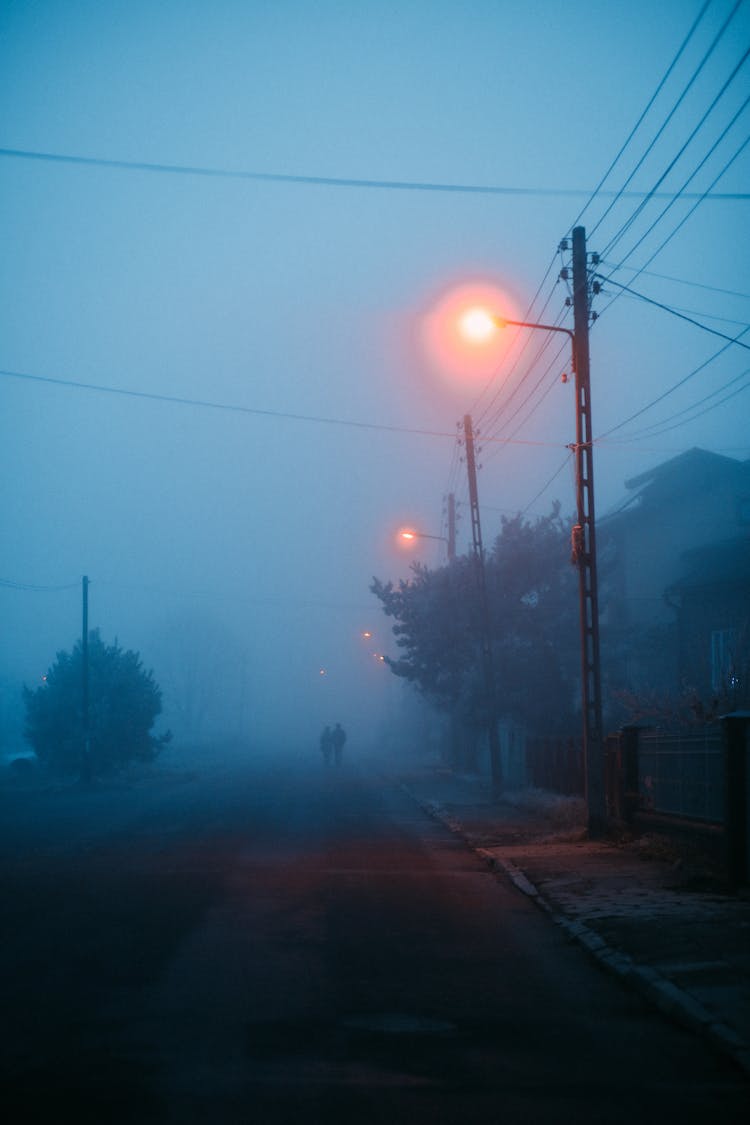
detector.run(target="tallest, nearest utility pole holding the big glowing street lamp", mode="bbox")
[572,226,606,836]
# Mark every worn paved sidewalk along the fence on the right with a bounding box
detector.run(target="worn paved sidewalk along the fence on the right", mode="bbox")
[400,768,750,1076]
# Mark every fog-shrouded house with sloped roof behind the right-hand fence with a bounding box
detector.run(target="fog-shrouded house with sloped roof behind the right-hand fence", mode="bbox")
[597,449,750,698]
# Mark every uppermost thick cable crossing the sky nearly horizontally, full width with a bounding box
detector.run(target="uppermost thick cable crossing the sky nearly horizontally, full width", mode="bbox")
[0,149,750,200]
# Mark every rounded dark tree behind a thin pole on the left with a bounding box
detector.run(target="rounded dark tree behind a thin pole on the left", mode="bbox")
[24,630,171,774]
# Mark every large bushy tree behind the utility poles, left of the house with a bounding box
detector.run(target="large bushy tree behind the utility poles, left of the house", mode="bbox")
[370,504,580,734]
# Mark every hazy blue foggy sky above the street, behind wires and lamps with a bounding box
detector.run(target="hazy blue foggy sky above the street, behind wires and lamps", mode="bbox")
[0,0,750,753]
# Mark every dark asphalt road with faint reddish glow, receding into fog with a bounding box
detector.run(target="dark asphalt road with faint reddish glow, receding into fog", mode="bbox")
[0,759,749,1125]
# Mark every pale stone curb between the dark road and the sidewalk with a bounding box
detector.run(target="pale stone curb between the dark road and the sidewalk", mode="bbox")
[411,785,750,1078]
